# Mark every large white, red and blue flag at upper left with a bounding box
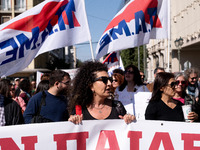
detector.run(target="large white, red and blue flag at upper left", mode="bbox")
[0,0,91,76]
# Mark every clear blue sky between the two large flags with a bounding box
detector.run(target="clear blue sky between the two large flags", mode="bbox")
[76,0,124,61]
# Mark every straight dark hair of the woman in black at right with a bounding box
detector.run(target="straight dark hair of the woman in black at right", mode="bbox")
[150,72,174,101]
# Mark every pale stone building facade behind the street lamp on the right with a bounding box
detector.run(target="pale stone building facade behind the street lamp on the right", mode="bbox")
[147,0,200,81]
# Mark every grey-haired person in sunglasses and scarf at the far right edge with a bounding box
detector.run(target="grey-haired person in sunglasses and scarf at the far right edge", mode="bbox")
[185,68,199,101]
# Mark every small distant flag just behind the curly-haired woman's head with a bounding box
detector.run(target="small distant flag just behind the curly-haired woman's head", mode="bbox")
[103,51,124,76]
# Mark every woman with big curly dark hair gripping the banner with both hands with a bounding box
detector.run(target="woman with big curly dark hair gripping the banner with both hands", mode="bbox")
[69,61,135,124]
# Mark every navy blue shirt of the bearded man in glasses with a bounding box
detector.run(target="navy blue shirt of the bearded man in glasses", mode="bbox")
[23,91,68,123]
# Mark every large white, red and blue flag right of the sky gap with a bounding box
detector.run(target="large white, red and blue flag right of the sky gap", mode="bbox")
[96,0,168,59]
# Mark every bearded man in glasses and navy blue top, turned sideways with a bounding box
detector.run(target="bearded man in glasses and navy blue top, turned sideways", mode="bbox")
[23,70,70,123]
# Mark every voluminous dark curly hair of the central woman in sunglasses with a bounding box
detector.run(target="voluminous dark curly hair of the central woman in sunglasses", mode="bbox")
[69,61,108,112]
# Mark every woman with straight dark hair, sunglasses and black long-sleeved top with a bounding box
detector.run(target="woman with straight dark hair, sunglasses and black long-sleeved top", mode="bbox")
[145,72,184,121]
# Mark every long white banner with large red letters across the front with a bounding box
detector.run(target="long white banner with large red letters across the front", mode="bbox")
[0,120,200,150]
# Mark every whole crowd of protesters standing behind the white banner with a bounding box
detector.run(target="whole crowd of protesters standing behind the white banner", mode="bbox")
[0,61,200,126]
